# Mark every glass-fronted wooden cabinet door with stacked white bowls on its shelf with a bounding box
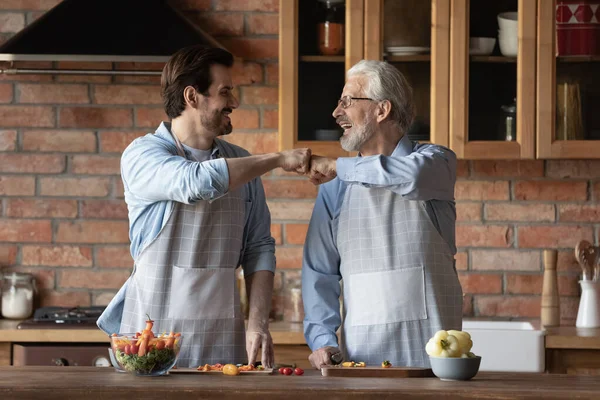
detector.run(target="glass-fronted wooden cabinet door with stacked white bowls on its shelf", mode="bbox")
[450,0,543,159]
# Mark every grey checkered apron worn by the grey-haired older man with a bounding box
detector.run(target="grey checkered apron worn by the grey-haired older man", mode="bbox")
[337,184,462,367]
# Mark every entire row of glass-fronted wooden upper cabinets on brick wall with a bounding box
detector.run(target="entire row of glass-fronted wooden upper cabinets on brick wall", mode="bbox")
[279,0,600,159]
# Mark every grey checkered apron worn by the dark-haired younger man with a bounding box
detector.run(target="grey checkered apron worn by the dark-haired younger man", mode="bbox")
[120,132,249,367]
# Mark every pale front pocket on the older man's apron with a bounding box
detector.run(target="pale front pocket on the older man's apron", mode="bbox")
[345,267,427,326]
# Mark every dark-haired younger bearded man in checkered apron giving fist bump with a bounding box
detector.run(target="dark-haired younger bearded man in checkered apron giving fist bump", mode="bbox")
[98,46,310,367]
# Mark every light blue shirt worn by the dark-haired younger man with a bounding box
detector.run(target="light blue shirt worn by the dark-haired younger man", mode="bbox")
[97,122,275,334]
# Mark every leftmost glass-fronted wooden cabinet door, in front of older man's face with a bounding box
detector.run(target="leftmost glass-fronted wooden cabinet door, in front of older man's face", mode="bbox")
[279,0,364,157]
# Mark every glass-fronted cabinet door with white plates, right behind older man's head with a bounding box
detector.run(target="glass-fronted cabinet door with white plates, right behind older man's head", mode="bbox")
[364,0,450,146]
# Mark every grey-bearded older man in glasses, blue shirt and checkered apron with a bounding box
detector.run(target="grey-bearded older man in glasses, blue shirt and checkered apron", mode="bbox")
[302,60,462,368]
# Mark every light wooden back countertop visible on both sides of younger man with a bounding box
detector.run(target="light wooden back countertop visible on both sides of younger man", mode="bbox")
[0,319,306,345]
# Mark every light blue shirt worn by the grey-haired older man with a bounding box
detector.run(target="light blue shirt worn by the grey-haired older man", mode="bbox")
[302,135,456,350]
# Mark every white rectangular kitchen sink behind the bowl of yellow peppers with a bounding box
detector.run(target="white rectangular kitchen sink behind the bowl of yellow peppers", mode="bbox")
[463,320,545,372]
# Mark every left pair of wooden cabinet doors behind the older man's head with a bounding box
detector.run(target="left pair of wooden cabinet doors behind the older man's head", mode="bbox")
[279,0,450,157]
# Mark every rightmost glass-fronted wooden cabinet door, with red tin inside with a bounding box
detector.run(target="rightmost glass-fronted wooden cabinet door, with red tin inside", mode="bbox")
[537,0,600,159]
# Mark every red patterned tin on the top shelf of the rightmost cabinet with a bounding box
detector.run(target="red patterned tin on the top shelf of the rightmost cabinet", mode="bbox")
[556,0,600,56]
